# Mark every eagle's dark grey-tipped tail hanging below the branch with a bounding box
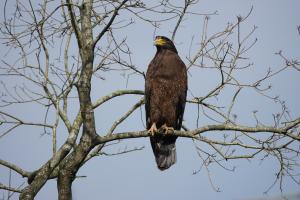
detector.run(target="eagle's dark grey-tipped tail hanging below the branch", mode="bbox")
[150,137,176,170]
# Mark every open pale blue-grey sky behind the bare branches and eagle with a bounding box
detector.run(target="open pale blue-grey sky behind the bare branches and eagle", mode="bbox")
[0,0,300,200]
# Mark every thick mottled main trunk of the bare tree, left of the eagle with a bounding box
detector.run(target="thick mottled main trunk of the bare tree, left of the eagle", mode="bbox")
[57,0,97,200]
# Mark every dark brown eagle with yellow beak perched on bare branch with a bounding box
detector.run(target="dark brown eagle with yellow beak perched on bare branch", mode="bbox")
[145,36,187,170]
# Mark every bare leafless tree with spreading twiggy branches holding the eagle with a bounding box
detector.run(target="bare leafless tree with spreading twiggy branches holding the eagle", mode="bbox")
[0,0,300,199]
